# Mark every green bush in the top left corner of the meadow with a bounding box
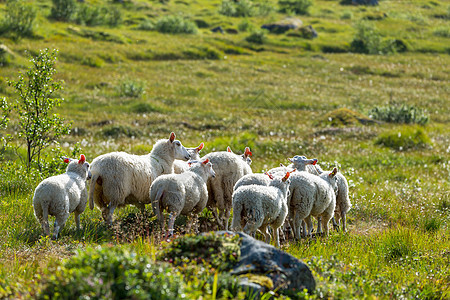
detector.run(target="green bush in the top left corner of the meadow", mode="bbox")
[0,0,36,39]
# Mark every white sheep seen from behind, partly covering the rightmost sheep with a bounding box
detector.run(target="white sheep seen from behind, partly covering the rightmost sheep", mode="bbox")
[287,168,337,239]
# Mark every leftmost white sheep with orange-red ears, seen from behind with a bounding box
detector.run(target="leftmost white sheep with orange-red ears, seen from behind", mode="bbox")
[33,154,91,239]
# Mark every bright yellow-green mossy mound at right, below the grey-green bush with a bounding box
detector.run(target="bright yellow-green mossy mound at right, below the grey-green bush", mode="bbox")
[375,126,431,151]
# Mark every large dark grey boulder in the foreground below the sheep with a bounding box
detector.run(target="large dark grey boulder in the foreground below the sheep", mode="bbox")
[218,231,316,293]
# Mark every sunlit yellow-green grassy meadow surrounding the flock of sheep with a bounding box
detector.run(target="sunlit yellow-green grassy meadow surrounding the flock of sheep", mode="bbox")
[0,0,450,299]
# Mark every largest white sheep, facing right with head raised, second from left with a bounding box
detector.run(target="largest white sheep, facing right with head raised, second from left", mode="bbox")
[89,132,191,225]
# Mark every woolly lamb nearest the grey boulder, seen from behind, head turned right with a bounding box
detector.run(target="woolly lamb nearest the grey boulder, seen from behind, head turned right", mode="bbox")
[231,172,290,247]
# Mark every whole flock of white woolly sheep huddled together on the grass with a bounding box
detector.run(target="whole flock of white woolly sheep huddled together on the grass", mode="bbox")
[33,132,351,247]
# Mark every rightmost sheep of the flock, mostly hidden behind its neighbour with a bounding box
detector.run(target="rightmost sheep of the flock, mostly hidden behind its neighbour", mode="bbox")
[314,165,352,232]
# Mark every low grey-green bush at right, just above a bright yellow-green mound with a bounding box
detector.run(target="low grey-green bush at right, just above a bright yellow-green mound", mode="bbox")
[369,103,429,125]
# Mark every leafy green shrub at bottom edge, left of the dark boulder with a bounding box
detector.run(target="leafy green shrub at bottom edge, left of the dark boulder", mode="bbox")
[37,246,184,299]
